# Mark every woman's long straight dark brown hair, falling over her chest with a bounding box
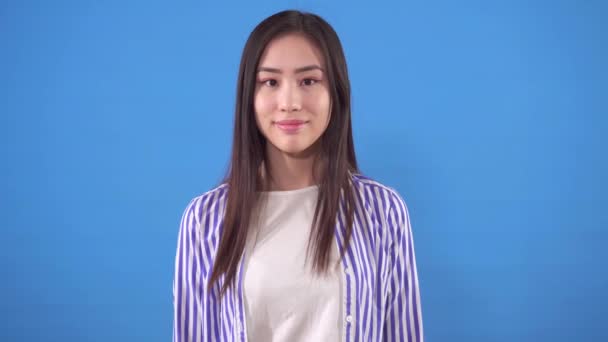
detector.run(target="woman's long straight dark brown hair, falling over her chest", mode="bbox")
[208,11,358,295]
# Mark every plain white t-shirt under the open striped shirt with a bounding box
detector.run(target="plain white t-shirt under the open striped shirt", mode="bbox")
[243,185,343,342]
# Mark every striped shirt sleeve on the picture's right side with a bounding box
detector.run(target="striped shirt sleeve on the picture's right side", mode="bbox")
[383,194,424,342]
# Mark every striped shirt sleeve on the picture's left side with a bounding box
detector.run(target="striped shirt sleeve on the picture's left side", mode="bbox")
[173,199,203,342]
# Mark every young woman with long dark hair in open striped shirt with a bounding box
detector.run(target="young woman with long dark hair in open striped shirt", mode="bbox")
[173,11,423,342]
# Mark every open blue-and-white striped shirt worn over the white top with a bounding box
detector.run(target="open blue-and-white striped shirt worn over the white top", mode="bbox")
[173,174,424,342]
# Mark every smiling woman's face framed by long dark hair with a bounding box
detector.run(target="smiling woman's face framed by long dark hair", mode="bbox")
[254,34,331,157]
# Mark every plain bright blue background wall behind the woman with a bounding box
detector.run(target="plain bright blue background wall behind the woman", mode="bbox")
[0,0,608,342]
